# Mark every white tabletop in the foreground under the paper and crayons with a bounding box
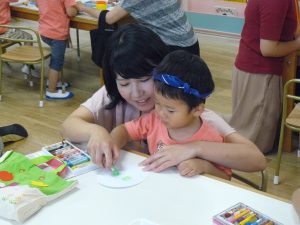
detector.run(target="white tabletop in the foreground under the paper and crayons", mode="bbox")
[0,149,299,225]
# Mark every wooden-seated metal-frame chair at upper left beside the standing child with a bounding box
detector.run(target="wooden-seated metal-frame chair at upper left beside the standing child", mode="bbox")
[0,25,51,107]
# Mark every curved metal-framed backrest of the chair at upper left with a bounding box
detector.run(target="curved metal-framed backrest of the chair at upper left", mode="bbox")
[0,24,44,58]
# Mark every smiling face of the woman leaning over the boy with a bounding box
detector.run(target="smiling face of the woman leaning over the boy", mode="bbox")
[116,75,154,112]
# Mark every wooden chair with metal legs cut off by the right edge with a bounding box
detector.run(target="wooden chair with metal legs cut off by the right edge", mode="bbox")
[273,79,300,184]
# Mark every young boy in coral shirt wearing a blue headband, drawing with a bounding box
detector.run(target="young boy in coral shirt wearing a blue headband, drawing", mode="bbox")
[111,50,231,179]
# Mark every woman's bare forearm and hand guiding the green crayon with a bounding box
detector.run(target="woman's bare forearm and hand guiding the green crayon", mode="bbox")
[61,106,119,168]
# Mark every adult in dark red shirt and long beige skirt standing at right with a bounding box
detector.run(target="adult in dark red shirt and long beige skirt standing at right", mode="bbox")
[229,0,300,153]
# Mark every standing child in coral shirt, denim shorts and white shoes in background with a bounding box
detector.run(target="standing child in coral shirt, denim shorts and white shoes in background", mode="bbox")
[36,0,77,99]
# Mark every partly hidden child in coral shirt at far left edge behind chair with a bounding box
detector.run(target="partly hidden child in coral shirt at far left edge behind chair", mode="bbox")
[0,0,40,77]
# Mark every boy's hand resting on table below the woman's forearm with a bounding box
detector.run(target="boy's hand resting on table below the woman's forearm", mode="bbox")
[177,158,207,177]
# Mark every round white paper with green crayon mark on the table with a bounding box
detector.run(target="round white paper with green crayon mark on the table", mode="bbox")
[97,165,147,188]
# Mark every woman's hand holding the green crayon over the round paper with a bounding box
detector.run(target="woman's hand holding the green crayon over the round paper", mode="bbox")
[87,125,120,168]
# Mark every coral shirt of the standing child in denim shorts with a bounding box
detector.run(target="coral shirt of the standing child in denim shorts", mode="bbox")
[37,0,76,40]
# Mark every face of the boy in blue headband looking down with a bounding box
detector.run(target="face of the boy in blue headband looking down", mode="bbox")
[154,91,201,129]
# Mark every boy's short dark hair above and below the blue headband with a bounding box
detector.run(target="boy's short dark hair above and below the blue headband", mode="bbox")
[154,50,215,110]
